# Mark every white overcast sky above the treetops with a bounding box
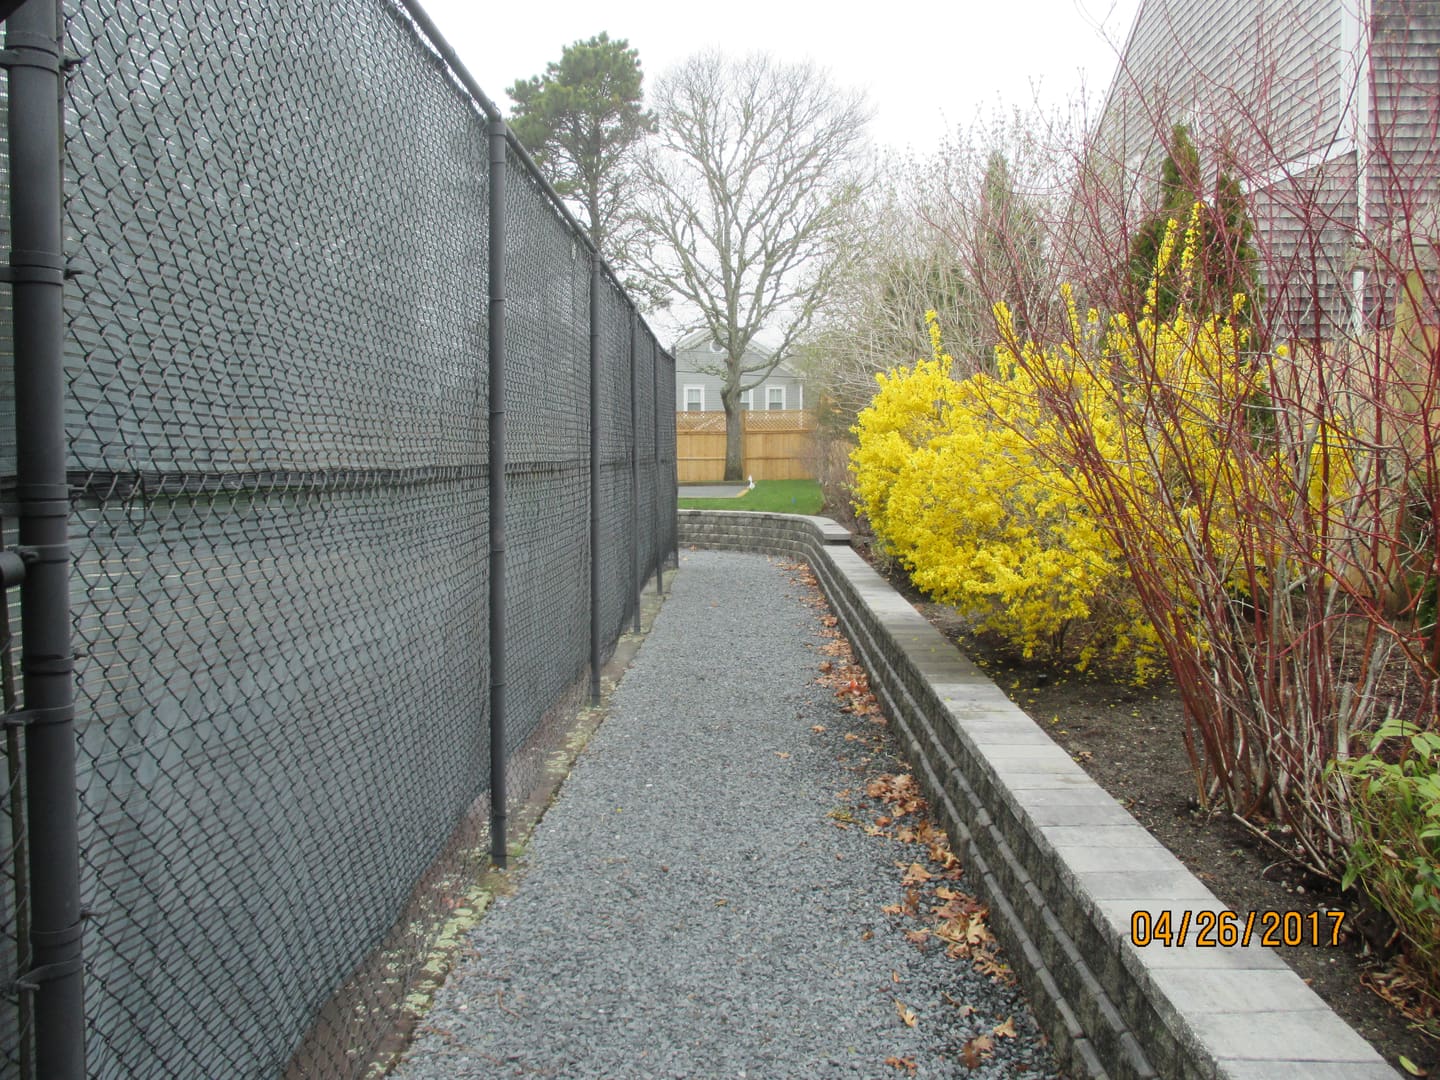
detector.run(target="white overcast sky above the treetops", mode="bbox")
[422,0,1134,154]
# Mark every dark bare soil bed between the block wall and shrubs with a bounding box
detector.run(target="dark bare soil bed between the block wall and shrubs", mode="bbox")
[855,537,1440,1077]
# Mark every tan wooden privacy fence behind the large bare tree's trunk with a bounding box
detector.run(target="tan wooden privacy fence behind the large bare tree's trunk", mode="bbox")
[675,409,815,484]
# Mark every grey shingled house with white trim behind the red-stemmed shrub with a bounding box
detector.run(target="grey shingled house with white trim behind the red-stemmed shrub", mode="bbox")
[1094,0,1440,337]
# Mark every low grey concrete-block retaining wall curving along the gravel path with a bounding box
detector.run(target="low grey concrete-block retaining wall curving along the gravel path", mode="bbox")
[680,510,1398,1080]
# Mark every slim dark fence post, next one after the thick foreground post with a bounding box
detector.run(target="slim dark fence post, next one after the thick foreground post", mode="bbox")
[487,120,508,870]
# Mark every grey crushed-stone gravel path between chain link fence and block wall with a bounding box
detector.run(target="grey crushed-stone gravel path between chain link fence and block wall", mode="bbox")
[396,552,1056,1080]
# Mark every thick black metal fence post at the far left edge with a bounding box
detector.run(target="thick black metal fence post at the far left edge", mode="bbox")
[4,0,85,1080]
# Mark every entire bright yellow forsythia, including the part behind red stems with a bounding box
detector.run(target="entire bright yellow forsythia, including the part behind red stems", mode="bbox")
[851,204,1354,680]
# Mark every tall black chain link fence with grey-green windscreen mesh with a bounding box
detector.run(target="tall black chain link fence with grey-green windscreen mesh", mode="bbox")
[0,0,677,1079]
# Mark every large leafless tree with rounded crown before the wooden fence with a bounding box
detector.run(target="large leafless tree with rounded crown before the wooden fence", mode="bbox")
[641,52,870,480]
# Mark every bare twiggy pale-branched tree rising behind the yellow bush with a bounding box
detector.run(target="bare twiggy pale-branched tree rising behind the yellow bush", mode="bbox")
[799,108,1074,513]
